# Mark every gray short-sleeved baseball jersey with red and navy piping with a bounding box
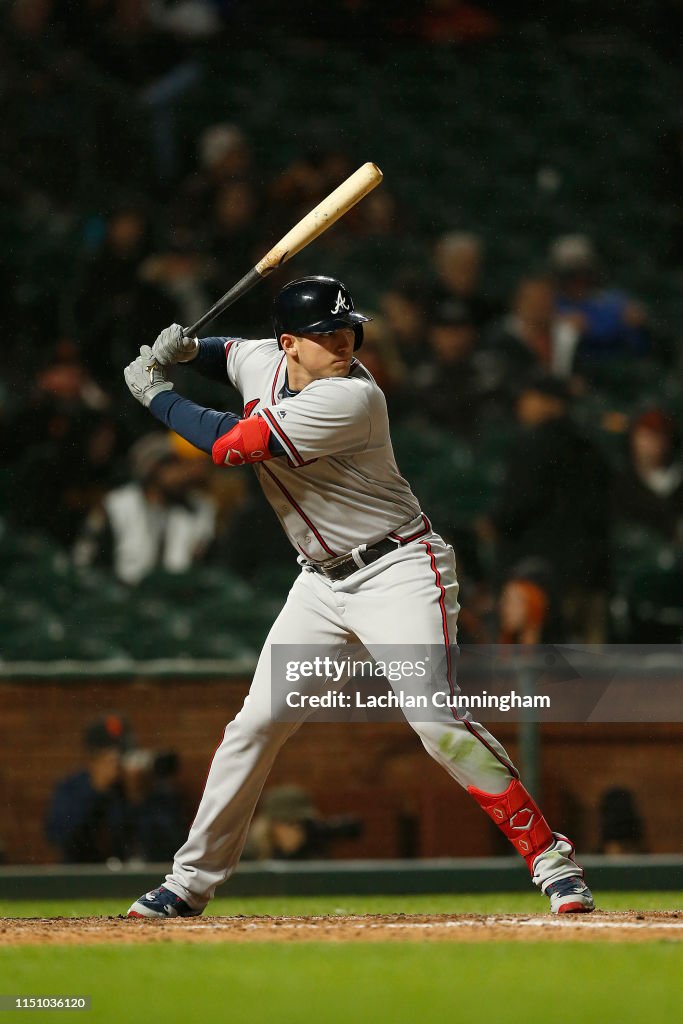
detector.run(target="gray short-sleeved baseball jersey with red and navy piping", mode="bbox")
[225,339,426,561]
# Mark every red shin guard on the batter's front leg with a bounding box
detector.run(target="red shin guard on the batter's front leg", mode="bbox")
[467,778,555,874]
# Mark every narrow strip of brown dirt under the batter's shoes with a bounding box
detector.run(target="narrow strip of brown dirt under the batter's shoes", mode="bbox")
[0,910,683,946]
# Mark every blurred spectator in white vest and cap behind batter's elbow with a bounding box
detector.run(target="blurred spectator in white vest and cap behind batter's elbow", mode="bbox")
[74,432,216,586]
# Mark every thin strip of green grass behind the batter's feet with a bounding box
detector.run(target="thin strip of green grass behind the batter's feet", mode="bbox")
[0,890,683,918]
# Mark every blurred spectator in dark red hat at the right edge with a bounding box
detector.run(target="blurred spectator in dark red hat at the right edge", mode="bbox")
[612,409,683,543]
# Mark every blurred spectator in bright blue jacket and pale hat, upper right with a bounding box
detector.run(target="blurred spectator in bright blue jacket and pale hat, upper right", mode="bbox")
[550,234,651,375]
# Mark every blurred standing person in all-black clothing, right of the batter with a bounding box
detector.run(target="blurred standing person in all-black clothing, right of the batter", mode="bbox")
[483,375,609,643]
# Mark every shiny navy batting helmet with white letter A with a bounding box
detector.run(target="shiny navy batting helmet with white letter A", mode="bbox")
[272,278,372,349]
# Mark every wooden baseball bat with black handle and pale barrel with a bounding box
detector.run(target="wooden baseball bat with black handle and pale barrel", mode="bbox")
[182,163,383,338]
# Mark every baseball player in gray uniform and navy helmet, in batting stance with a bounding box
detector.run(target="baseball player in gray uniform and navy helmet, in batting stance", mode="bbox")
[125,276,594,918]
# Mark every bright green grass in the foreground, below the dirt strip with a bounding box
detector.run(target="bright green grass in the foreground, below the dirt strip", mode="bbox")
[0,942,683,1024]
